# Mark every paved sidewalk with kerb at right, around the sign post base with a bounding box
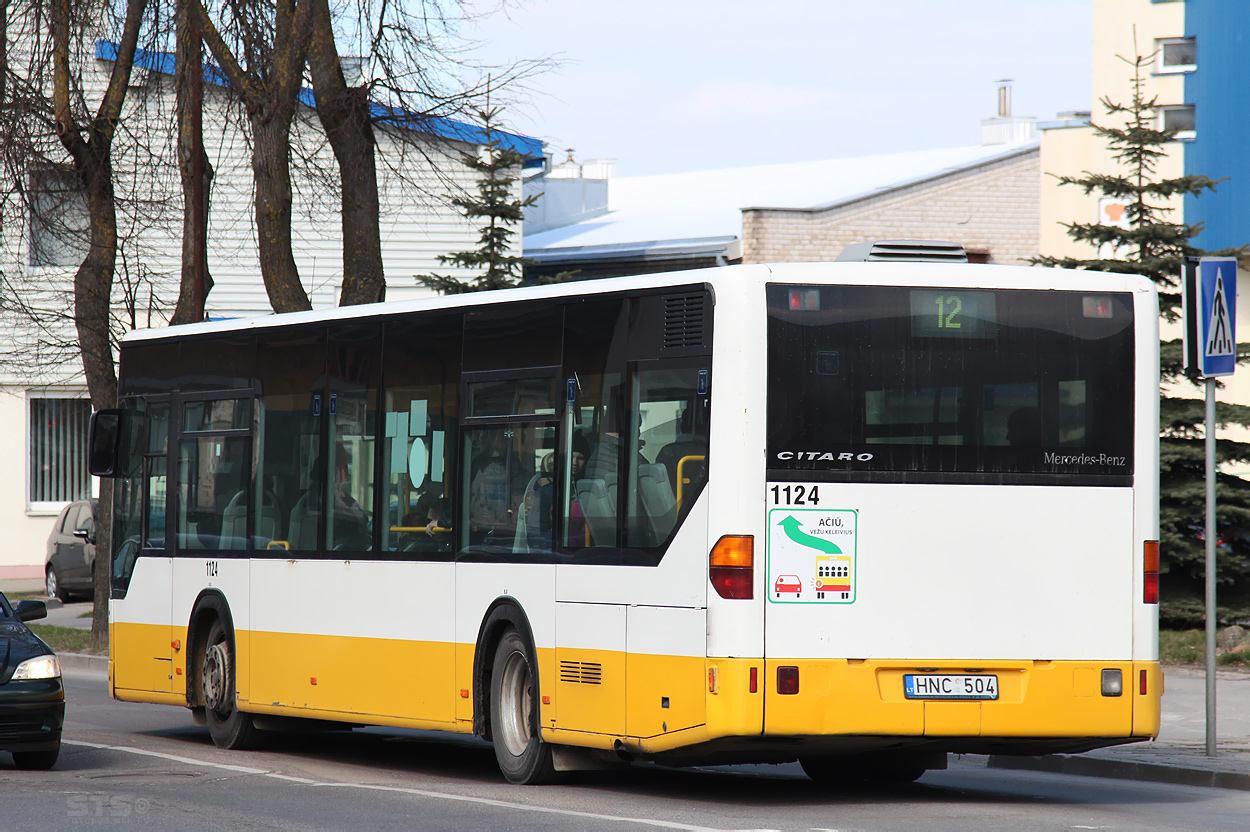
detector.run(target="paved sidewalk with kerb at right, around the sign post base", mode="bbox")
[989,667,1250,791]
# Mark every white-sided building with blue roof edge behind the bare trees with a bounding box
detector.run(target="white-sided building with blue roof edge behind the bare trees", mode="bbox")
[0,37,543,587]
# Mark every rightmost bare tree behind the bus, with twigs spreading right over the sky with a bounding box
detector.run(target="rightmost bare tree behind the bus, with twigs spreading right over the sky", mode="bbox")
[308,0,553,305]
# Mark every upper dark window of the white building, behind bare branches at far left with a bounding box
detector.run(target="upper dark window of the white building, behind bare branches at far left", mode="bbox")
[28,167,90,269]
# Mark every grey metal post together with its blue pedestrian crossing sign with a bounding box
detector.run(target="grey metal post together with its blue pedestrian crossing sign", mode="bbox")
[1181,257,1238,757]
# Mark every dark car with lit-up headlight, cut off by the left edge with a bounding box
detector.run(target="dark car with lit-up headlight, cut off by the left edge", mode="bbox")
[0,592,65,770]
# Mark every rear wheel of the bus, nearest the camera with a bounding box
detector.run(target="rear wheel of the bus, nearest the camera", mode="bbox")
[490,628,559,786]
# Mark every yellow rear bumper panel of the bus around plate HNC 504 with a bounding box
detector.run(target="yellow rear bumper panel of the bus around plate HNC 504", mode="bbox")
[764,660,1159,738]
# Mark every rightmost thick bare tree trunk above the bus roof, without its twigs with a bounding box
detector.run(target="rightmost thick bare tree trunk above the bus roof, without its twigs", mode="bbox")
[308,0,386,306]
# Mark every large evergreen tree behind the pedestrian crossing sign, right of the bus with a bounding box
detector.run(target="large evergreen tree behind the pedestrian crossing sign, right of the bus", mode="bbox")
[1033,55,1250,626]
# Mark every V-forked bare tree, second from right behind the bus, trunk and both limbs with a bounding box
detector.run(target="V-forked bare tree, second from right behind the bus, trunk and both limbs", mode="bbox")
[195,0,313,312]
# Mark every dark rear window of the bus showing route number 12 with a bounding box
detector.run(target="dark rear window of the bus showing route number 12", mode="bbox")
[768,284,1134,485]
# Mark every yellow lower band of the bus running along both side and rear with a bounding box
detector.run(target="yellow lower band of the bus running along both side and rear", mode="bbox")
[109,614,1161,755]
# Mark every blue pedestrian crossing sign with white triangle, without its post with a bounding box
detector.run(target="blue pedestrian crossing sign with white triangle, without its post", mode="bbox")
[1185,257,1238,379]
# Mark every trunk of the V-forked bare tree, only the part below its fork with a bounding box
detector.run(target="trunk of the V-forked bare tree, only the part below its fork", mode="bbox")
[251,111,313,312]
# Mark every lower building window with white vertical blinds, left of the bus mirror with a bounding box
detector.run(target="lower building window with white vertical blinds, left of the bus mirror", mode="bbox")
[28,397,91,510]
